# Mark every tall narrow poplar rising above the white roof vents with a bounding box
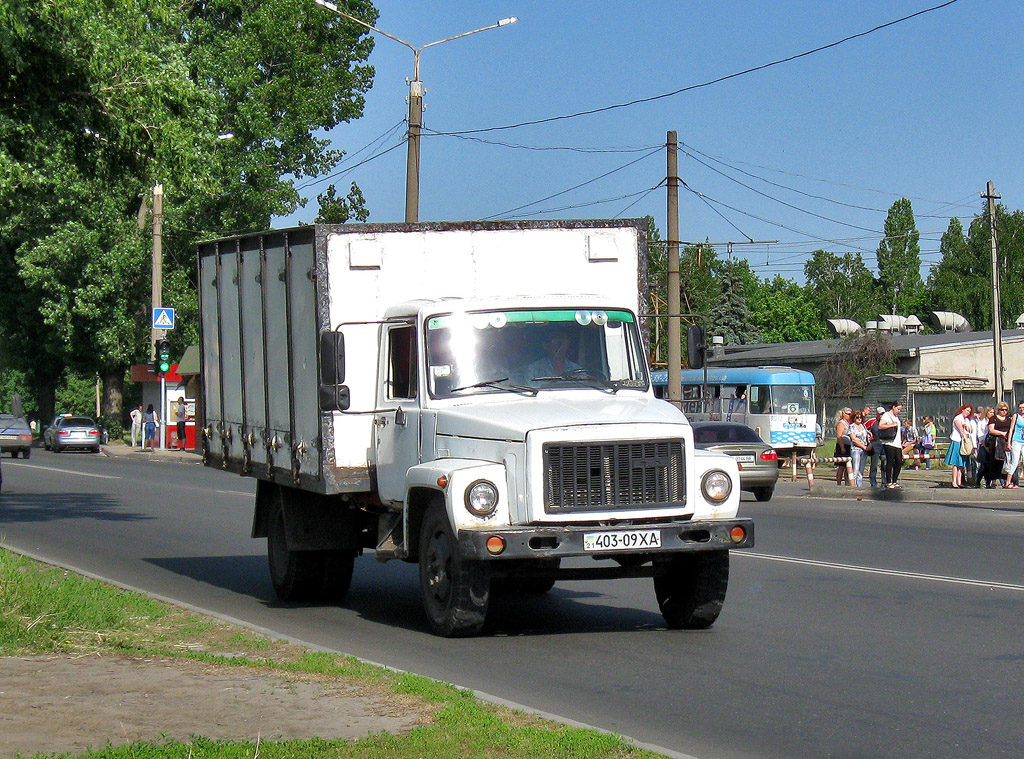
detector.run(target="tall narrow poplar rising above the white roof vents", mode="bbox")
[878,198,925,315]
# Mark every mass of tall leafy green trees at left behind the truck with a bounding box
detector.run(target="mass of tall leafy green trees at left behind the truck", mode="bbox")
[0,0,376,415]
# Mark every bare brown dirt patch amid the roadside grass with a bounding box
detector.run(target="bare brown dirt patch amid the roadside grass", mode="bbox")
[0,655,430,759]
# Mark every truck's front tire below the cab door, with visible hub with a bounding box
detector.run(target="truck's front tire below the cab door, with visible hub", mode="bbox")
[420,503,490,638]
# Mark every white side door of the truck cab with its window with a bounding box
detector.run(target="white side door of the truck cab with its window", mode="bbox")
[374,323,420,502]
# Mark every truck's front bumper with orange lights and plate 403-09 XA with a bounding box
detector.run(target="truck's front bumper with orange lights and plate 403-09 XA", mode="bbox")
[459,518,754,560]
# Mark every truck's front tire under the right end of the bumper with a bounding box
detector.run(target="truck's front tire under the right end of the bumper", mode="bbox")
[654,551,729,630]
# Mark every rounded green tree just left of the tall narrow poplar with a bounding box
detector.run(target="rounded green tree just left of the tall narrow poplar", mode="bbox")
[804,250,878,324]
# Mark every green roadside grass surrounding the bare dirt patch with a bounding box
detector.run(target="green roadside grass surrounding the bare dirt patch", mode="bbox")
[0,548,658,759]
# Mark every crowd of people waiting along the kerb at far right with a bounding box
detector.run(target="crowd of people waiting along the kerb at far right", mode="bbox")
[836,400,1024,489]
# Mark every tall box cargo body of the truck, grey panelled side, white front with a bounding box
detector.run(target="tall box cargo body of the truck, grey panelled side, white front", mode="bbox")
[200,222,646,493]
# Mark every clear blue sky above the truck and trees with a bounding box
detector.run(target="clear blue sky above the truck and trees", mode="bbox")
[275,0,1024,281]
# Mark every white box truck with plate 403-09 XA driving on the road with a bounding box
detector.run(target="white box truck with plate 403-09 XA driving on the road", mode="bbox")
[199,220,754,636]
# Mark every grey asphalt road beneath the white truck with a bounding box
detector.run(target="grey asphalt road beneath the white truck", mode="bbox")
[0,450,1024,759]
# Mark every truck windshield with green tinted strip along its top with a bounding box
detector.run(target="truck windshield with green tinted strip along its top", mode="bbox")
[426,308,648,397]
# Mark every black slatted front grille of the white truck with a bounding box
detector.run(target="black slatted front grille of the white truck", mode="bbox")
[544,440,686,513]
